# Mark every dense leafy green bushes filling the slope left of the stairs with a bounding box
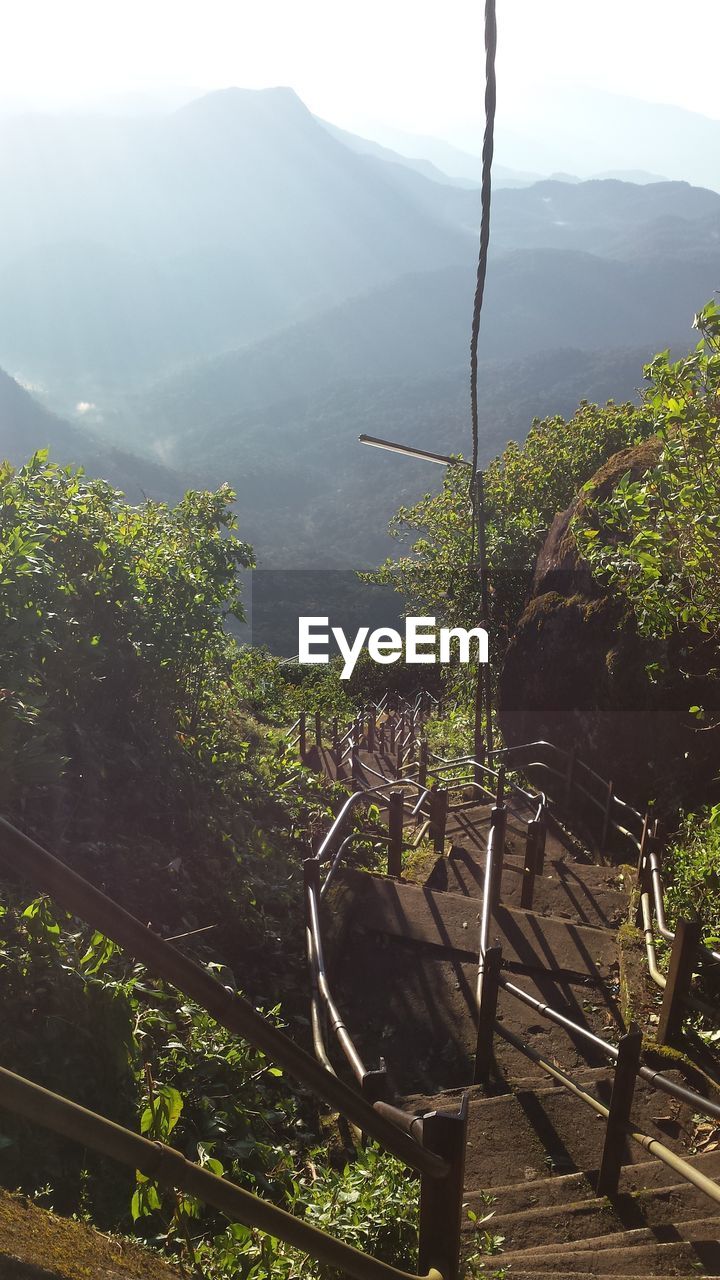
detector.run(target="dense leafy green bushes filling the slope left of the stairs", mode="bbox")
[0,456,415,1276]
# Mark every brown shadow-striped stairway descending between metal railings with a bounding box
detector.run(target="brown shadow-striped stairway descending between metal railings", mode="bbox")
[324,756,720,1280]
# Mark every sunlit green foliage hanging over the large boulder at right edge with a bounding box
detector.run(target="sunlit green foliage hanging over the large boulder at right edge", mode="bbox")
[577,302,720,730]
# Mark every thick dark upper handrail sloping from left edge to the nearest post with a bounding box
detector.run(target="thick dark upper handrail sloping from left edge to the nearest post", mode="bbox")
[0,818,445,1176]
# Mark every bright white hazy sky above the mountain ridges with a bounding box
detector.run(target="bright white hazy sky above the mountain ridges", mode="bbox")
[0,0,720,146]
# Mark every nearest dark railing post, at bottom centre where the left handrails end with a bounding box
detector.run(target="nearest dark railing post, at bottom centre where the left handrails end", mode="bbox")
[418,1093,468,1280]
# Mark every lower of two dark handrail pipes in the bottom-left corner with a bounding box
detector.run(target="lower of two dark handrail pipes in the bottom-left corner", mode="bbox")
[0,1068,442,1280]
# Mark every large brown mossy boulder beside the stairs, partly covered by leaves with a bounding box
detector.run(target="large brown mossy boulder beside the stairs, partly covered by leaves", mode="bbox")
[500,440,720,812]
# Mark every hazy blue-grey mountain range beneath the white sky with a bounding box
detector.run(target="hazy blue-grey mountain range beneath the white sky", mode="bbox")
[0,90,720,567]
